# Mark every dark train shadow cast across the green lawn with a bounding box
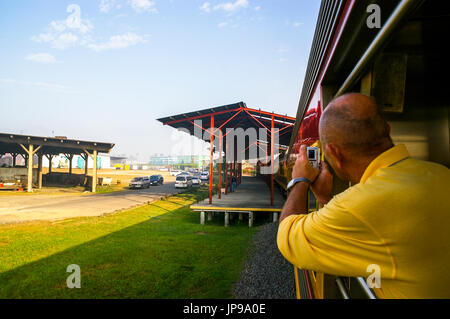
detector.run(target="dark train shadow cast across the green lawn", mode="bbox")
[0,194,255,298]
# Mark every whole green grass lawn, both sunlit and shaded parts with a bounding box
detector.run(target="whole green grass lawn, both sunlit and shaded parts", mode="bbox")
[0,190,256,298]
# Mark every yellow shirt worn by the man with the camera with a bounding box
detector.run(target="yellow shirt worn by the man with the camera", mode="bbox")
[277,145,450,298]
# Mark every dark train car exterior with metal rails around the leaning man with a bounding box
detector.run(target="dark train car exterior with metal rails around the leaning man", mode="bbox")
[275,0,450,298]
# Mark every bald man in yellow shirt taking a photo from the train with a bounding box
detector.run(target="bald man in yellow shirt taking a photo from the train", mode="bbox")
[277,93,450,298]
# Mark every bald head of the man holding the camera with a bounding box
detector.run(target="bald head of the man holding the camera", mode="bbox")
[319,93,392,156]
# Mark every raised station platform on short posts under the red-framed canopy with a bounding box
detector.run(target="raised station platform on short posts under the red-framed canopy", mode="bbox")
[190,176,284,227]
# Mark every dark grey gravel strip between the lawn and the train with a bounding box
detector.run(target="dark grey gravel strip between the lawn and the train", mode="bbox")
[234,223,296,299]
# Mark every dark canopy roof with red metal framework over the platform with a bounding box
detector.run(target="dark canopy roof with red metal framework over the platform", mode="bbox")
[158,102,296,158]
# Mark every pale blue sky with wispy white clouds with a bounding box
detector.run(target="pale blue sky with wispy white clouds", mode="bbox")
[0,0,320,160]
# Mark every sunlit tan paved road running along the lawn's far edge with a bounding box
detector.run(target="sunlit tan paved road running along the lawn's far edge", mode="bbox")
[0,182,185,224]
